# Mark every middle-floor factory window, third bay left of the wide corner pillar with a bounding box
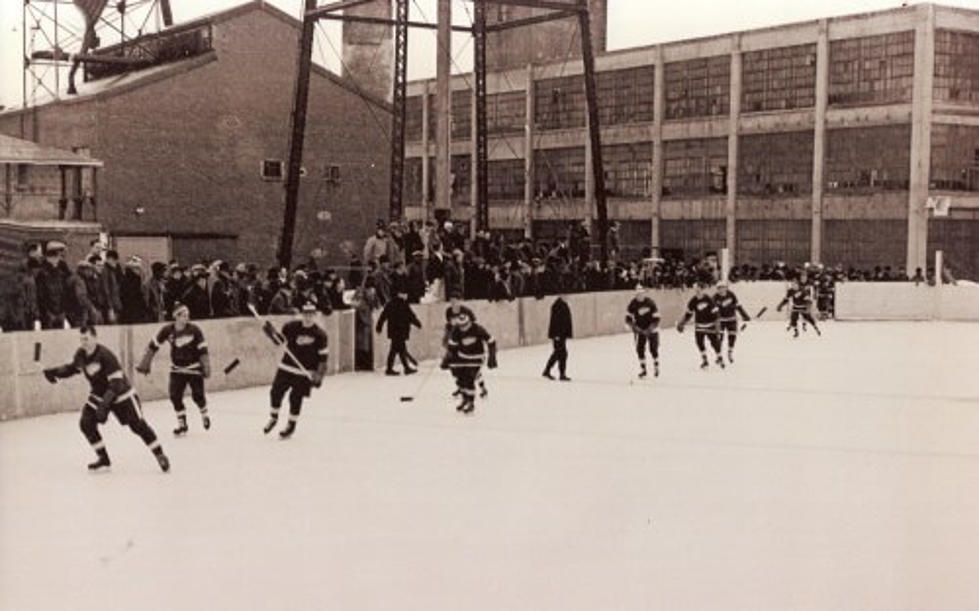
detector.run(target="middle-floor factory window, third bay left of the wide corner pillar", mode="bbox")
[663,138,727,197]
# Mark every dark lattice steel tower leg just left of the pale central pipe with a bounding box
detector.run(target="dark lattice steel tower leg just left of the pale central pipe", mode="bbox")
[388,0,408,221]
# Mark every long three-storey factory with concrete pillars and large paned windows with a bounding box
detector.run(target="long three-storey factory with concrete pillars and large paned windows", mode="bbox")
[406,4,979,278]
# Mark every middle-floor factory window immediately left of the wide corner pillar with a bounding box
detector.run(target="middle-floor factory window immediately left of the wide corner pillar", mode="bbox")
[824,125,911,193]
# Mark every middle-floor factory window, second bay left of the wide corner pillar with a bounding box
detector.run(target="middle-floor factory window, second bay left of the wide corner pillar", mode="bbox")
[738,132,812,197]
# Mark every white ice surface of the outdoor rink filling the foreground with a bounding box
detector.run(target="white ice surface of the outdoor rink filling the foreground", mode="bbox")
[0,322,979,611]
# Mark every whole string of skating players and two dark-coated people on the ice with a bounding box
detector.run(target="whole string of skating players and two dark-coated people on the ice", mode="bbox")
[44,276,825,472]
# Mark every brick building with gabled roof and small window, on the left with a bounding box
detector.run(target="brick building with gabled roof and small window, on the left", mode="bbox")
[0,1,390,264]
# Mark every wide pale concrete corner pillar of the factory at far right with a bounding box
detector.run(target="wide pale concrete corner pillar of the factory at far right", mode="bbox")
[905,4,935,270]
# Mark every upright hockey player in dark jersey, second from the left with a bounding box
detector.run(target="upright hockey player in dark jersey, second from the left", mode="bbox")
[136,303,211,435]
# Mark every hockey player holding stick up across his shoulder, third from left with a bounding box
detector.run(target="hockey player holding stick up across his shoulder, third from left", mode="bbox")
[262,301,329,439]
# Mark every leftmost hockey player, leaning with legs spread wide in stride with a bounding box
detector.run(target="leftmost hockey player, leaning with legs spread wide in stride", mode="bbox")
[44,325,170,472]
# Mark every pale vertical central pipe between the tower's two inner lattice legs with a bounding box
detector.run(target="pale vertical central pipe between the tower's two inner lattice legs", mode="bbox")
[435,0,452,218]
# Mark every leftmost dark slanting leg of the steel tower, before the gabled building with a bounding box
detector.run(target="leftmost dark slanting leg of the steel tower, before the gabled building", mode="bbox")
[277,0,316,267]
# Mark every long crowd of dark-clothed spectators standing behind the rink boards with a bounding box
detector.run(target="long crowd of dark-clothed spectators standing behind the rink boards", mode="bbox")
[4,221,956,330]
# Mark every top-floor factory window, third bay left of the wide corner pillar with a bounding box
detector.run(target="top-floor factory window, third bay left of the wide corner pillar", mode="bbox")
[664,55,731,119]
